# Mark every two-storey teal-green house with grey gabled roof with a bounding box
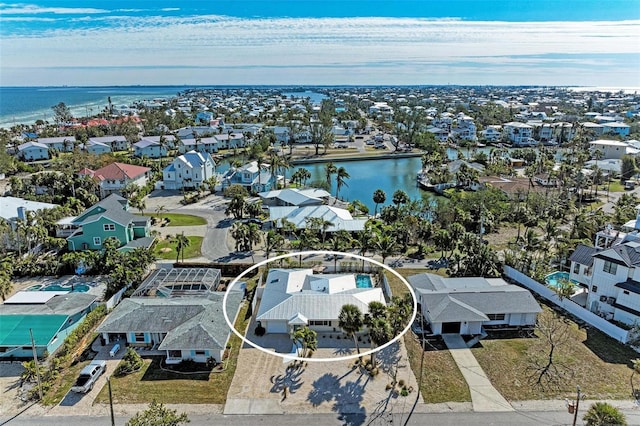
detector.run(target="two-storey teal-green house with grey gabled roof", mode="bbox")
[63,194,154,251]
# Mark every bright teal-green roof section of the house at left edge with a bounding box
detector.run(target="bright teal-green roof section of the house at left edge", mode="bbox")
[0,315,69,347]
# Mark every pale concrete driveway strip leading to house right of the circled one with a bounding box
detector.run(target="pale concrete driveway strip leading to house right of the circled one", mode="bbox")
[442,334,514,412]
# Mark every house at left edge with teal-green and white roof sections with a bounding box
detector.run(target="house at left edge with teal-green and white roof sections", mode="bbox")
[0,291,97,360]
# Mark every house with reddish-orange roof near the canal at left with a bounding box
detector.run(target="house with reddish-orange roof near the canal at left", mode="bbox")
[78,163,151,198]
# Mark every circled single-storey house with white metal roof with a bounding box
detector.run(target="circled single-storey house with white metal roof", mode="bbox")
[256,269,386,334]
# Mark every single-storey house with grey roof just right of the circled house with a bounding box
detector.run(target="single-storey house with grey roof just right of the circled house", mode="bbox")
[408,273,542,335]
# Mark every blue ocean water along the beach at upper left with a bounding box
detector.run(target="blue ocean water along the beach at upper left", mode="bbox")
[0,86,191,127]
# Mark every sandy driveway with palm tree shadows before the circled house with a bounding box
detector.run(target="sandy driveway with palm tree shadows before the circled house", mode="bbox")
[225,343,418,417]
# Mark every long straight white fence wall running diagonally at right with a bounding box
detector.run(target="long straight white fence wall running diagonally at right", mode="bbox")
[504,265,629,343]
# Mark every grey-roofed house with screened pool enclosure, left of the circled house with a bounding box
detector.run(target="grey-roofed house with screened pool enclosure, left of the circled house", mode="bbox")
[97,268,244,364]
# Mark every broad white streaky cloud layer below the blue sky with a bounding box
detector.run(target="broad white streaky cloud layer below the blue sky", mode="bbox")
[0,15,640,86]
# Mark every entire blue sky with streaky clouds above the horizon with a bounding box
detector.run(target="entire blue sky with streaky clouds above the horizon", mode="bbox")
[0,0,640,87]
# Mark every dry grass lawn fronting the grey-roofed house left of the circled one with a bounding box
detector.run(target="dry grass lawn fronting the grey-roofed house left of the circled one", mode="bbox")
[95,286,254,404]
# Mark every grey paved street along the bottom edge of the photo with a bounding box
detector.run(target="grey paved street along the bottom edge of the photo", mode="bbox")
[8,410,640,426]
